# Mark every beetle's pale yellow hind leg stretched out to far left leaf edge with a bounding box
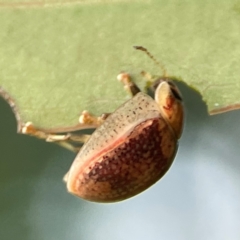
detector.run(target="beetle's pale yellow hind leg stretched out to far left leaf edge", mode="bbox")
[22,122,90,152]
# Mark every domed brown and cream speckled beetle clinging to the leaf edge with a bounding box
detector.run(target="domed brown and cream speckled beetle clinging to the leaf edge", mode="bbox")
[24,47,184,203]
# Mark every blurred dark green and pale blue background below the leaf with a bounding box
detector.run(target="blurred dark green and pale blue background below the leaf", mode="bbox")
[0,81,240,240]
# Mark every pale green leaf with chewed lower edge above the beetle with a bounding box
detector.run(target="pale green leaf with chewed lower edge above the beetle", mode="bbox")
[0,0,240,128]
